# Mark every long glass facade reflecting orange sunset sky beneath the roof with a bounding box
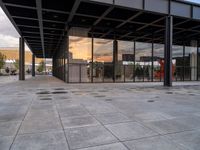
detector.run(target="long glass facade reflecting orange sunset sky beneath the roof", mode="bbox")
[54,35,200,83]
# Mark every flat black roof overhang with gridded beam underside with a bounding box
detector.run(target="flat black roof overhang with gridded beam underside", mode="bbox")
[0,0,200,58]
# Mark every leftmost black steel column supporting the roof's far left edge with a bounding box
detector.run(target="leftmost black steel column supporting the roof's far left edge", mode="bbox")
[19,37,25,80]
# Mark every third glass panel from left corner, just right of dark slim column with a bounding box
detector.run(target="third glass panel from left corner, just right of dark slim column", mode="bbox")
[116,41,134,82]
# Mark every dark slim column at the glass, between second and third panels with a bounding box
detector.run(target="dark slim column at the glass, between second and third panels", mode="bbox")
[113,40,118,82]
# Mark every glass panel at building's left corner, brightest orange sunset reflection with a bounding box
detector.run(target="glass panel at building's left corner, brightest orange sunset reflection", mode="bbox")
[69,36,92,82]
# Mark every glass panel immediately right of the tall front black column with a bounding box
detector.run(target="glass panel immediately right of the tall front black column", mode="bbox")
[172,45,184,81]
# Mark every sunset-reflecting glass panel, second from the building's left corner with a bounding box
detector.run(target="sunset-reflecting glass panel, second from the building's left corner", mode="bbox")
[93,38,113,82]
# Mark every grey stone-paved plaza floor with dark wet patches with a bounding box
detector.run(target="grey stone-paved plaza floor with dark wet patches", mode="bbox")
[0,76,200,150]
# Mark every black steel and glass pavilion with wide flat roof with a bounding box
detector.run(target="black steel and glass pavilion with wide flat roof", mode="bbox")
[0,0,200,86]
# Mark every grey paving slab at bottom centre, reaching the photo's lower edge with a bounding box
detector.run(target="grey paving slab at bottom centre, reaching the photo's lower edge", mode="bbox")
[65,126,117,149]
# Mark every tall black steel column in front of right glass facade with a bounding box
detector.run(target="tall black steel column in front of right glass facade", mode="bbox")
[164,16,173,86]
